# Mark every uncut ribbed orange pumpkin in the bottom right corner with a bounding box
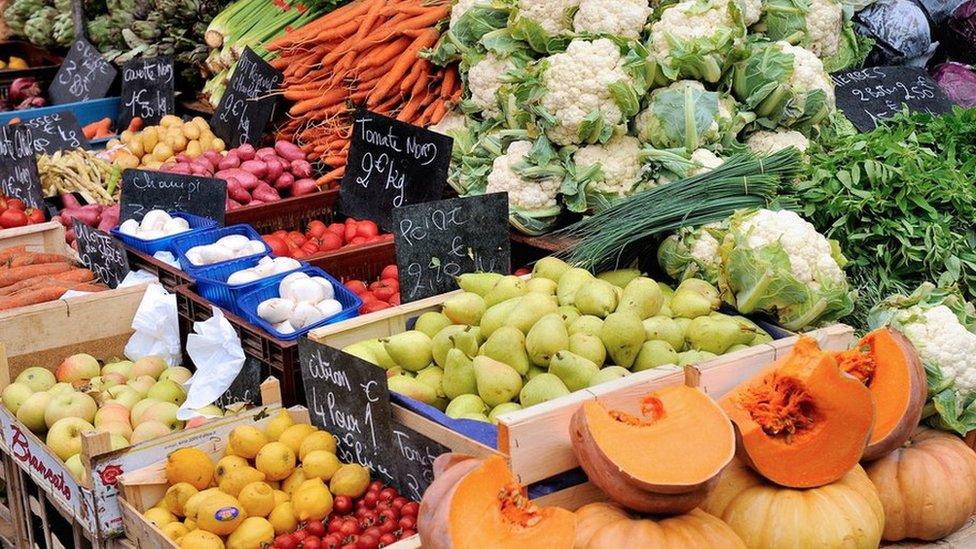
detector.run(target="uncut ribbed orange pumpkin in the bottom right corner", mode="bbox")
[867,427,976,541]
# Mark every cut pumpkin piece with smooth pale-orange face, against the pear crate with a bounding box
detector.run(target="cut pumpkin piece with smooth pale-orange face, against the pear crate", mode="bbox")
[570,385,735,514]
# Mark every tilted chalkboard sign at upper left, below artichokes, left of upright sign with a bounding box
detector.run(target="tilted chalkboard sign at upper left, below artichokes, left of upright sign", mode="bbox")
[47,38,118,105]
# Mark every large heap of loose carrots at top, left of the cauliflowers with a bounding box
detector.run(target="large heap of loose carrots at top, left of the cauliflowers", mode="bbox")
[268,0,461,187]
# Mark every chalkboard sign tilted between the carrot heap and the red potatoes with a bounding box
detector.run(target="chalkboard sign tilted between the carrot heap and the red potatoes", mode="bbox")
[210,48,284,148]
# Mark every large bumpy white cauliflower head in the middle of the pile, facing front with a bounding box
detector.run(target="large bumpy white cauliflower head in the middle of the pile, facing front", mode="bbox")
[541,38,630,145]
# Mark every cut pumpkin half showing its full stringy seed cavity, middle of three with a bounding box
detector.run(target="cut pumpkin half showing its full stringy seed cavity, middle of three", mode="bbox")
[721,337,874,488]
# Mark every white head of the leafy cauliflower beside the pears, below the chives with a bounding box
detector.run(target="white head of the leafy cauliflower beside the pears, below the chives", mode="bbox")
[742,210,846,288]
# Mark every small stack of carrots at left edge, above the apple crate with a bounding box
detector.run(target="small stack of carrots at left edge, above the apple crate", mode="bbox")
[0,246,108,311]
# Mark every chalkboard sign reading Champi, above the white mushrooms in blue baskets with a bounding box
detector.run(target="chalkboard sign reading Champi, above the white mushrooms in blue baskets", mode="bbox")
[119,170,227,226]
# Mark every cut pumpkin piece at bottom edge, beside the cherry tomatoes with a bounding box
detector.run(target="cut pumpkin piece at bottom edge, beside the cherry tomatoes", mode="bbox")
[417,454,576,549]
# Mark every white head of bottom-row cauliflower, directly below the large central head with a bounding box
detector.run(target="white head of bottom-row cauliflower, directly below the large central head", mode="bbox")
[573,135,641,196]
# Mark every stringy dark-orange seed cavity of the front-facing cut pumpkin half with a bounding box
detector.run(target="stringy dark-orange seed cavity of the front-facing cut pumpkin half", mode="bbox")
[739,372,814,442]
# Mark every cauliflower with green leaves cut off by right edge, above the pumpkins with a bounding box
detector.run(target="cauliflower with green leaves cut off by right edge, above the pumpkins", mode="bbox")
[868,283,976,436]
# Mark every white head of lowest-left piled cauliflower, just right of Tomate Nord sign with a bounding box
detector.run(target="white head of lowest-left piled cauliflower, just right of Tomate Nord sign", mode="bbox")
[485,141,560,211]
